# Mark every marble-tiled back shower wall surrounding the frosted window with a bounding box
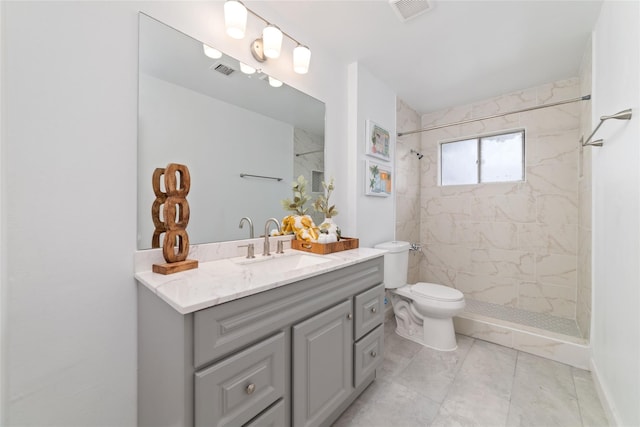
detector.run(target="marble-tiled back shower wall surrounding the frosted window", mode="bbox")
[418,78,586,319]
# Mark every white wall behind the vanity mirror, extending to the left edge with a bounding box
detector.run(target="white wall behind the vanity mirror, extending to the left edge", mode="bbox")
[0,1,395,426]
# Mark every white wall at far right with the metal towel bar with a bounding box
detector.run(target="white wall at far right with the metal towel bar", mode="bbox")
[591,1,640,426]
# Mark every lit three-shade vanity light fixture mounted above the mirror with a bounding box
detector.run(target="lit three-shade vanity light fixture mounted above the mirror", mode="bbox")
[224,0,311,74]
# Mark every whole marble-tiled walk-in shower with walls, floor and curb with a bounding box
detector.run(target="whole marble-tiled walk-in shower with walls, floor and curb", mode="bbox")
[396,48,592,368]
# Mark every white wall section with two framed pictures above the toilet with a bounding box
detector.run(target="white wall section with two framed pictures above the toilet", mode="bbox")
[350,63,396,251]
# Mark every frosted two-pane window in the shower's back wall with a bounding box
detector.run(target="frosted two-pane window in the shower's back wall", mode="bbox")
[440,130,524,185]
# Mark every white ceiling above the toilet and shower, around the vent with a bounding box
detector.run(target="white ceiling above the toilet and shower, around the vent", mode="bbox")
[258,0,602,113]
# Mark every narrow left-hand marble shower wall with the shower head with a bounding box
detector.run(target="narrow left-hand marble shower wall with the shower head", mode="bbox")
[395,99,424,283]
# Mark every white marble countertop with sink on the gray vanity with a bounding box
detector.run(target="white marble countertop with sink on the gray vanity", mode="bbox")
[135,248,385,314]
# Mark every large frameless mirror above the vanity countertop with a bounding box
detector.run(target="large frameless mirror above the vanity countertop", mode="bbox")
[138,14,325,249]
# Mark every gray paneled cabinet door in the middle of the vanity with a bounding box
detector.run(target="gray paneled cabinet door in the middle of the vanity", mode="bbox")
[291,300,353,427]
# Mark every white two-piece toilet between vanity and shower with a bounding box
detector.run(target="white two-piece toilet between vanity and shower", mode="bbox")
[375,241,465,351]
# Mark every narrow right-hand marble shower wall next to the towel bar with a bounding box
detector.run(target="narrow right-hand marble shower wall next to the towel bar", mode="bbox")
[576,38,598,338]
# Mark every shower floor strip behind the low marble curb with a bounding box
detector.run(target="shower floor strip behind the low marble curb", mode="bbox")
[465,299,582,338]
